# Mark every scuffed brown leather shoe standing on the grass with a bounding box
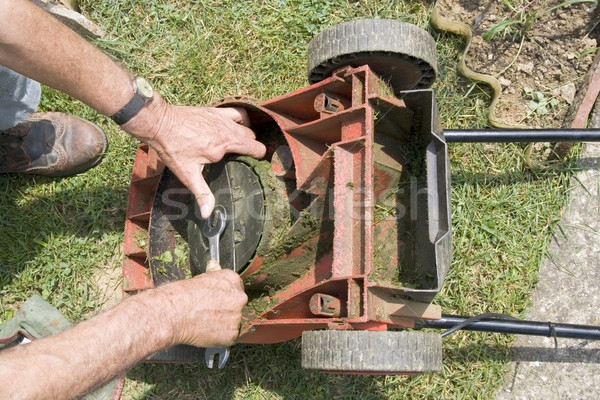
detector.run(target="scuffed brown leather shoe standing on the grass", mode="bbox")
[0,113,108,176]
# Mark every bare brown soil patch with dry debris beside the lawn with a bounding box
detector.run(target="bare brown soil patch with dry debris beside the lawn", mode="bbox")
[438,0,600,128]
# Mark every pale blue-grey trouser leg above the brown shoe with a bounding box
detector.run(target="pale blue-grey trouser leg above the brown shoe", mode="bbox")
[0,65,41,130]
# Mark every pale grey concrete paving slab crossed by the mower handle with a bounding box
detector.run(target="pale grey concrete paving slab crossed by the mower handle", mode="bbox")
[496,108,600,400]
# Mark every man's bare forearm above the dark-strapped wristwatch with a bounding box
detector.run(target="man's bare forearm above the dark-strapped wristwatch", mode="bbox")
[0,0,133,119]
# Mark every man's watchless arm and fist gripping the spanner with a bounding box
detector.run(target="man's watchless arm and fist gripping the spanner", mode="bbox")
[0,270,247,400]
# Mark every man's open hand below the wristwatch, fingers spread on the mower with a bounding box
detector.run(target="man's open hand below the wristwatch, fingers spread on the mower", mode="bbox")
[122,94,266,218]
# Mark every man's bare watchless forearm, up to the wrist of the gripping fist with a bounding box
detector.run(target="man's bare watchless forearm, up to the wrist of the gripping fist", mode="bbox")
[0,291,173,399]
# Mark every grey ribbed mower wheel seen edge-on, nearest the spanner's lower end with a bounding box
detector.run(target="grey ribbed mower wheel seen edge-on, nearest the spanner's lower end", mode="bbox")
[302,330,442,374]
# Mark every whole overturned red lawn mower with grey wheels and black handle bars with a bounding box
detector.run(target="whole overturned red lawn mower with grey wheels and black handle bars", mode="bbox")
[123,20,600,375]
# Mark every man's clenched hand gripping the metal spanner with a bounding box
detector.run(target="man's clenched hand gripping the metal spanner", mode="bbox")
[156,260,248,347]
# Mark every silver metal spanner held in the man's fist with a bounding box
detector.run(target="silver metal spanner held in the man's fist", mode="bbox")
[200,205,229,369]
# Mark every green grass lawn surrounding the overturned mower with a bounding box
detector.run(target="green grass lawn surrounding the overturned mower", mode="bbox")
[0,0,570,399]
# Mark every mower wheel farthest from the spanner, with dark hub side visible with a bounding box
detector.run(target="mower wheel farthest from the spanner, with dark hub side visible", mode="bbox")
[308,19,437,94]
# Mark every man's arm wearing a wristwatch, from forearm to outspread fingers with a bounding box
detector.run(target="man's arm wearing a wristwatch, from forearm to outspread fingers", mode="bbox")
[0,0,266,218]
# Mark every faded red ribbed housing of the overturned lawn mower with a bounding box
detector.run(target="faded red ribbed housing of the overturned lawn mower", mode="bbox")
[123,66,440,360]
